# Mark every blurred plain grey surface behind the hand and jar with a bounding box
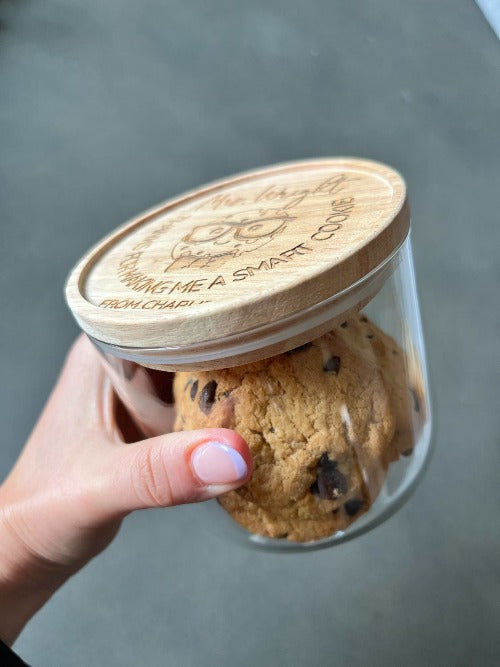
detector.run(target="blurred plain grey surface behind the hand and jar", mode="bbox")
[0,0,500,667]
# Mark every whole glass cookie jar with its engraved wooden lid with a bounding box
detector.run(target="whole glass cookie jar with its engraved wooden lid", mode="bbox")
[66,158,431,550]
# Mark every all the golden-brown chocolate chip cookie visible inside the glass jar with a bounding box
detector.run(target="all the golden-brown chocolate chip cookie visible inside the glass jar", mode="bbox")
[174,315,419,542]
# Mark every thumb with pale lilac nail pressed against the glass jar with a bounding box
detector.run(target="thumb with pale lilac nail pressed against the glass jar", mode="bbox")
[95,428,252,519]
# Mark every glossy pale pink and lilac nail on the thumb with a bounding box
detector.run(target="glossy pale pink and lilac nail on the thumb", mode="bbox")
[191,442,247,484]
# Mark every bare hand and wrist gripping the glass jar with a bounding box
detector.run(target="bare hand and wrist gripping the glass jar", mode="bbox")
[0,336,252,643]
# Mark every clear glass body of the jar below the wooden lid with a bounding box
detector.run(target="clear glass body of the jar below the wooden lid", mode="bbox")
[94,238,431,550]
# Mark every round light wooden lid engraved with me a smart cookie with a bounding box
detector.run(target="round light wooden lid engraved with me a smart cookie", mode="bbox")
[66,158,409,348]
